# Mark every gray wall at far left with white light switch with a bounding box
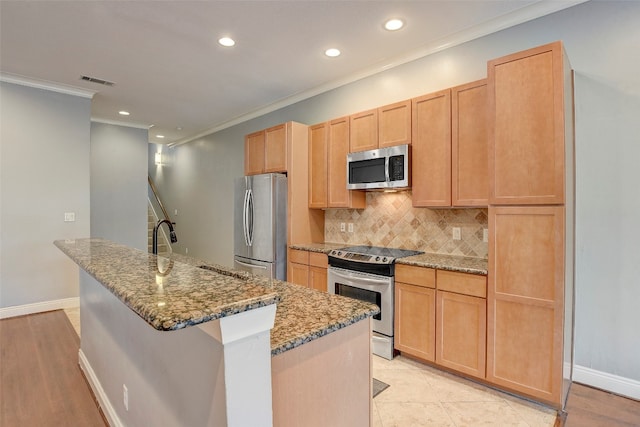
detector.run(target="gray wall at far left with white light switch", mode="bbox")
[0,82,91,308]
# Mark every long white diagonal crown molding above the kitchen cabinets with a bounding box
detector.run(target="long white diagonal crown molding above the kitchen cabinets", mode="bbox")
[168,0,589,147]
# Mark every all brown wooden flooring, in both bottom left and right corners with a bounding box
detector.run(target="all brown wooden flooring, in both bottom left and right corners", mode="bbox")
[0,310,640,427]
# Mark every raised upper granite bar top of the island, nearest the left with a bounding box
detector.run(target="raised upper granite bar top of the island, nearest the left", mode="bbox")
[54,239,279,331]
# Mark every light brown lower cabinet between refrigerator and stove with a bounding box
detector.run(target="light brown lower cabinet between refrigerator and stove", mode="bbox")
[287,249,329,292]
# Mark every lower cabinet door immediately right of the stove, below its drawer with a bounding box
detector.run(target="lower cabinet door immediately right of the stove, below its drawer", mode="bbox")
[394,282,436,362]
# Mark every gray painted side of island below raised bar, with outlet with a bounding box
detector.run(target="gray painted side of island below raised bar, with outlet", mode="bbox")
[80,270,227,426]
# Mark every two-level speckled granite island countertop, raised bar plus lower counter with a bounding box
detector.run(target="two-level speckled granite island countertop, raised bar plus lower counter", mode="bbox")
[55,239,378,356]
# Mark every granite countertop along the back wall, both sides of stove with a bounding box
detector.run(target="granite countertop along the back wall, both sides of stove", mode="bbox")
[289,243,488,276]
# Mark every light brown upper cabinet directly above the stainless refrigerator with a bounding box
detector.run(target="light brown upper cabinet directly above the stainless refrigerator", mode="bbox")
[244,123,288,175]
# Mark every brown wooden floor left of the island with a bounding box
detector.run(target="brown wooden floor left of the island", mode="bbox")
[0,310,106,427]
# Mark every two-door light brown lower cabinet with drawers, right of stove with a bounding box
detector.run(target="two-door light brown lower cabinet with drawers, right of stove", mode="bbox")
[395,264,487,379]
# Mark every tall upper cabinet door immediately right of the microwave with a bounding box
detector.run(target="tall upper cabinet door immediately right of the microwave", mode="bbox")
[411,89,451,207]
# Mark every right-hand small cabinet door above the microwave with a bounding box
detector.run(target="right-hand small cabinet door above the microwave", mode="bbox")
[378,100,411,148]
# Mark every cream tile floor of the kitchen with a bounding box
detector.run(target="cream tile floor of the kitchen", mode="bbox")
[65,308,556,427]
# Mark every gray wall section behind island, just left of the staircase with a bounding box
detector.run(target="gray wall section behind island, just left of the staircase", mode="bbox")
[91,122,148,251]
